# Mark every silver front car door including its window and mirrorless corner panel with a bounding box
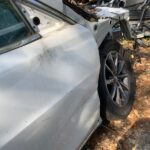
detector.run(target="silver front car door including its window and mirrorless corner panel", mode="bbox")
[0,0,100,150]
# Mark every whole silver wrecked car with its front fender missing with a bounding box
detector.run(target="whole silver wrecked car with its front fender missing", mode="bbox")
[0,0,135,150]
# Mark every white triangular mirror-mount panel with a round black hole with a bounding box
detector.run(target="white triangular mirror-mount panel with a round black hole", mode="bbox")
[17,2,66,36]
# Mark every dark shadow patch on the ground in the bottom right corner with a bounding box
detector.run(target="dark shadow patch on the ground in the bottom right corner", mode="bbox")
[117,118,150,150]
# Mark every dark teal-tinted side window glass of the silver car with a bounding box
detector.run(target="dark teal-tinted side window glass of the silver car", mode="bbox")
[0,0,31,49]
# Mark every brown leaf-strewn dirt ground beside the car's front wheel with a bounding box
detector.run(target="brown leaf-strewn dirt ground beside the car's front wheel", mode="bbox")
[83,40,150,150]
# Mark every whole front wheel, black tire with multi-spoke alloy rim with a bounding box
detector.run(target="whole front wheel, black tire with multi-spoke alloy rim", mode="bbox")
[98,40,135,120]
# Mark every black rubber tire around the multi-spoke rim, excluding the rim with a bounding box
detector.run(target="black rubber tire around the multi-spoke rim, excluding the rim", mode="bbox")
[99,41,135,119]
